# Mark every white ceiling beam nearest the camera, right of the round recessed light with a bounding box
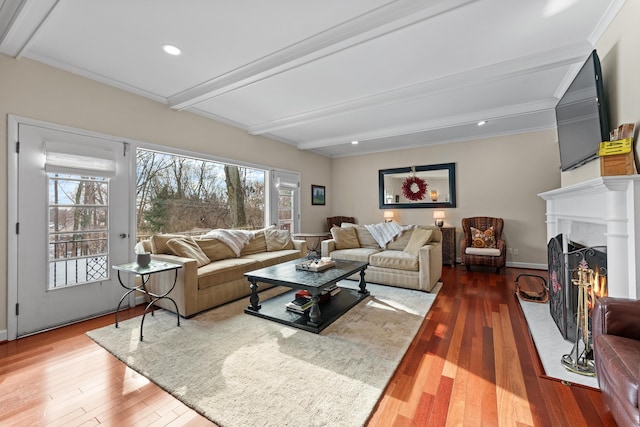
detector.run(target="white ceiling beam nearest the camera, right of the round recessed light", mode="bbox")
[169,0,478,110]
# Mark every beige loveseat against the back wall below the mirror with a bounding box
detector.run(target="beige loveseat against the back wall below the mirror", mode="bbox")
[322,223,442,292]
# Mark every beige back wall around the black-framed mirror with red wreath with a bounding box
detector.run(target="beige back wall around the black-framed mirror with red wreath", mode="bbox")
[328,130,560,266]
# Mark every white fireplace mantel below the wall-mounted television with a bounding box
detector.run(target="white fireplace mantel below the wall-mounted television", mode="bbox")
[538,175,640,299]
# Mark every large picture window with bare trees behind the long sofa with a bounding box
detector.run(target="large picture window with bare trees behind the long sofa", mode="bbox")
[136,149,266,240]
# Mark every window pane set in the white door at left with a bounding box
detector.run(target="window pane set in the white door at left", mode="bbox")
[47,173,109,289]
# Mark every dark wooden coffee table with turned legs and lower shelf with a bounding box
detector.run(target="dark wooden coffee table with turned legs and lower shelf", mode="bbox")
[244,258,369,334]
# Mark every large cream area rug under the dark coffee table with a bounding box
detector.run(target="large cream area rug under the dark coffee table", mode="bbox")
[87,280,439,427]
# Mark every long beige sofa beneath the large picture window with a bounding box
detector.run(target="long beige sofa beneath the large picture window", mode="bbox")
[140,227,307,317]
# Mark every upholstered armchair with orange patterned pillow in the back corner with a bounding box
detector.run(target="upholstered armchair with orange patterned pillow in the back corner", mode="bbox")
[460,216,507,273]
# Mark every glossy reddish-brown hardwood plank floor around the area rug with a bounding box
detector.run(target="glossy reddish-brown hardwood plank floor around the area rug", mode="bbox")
[0,266,615,427]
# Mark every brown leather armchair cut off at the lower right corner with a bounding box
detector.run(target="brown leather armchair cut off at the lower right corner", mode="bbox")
[592,297,640,426]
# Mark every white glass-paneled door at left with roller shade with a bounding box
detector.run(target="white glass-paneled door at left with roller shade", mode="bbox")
[16,124,131,336]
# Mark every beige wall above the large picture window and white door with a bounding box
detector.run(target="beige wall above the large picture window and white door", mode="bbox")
[0,54,331,336]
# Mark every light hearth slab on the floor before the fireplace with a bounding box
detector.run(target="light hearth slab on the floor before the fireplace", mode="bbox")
[518,299,598,388]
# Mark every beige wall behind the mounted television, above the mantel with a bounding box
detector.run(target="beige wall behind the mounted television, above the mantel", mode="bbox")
[561,0,640,187]
